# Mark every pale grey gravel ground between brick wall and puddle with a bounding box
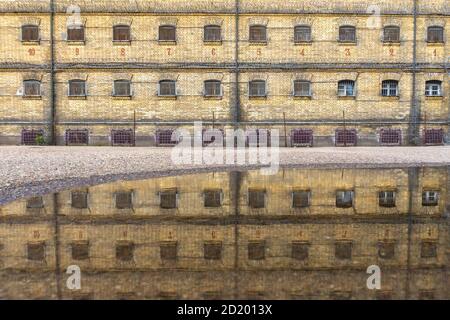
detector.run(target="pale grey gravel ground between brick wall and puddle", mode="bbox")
[0,146,450,204]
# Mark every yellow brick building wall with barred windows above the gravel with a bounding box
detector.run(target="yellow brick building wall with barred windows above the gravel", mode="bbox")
[0,0,450,146]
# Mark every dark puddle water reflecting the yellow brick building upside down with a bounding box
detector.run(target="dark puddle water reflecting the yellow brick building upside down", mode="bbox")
[0,168,450,299]
